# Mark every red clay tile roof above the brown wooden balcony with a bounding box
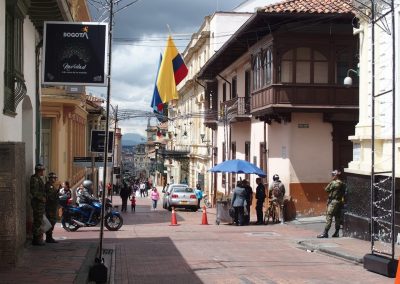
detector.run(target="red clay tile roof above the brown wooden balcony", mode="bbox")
[261,0,353,14]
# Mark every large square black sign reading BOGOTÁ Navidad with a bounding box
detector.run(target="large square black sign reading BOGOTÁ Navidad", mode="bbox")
[42,22,108,86]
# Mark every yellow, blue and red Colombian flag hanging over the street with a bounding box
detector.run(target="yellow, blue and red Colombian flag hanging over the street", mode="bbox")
[151,36,188,112]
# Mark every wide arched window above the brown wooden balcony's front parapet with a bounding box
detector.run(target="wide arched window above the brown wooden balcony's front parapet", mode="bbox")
[279,47,328,84]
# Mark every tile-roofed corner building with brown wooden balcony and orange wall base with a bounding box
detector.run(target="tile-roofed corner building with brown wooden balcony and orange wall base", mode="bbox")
[199,0,358,215]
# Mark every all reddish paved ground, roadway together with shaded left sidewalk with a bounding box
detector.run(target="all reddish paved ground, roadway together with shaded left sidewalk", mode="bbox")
[0,193,393,284]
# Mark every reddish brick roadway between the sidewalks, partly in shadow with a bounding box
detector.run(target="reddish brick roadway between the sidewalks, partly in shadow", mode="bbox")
[56,196,393,283]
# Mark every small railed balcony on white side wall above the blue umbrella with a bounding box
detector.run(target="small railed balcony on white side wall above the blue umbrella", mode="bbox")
[220,97,251,122]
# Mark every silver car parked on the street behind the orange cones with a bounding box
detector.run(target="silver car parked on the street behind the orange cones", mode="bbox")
[163,184,198,211]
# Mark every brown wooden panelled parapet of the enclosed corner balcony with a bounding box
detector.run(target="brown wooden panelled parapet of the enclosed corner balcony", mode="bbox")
[251,84,358,116]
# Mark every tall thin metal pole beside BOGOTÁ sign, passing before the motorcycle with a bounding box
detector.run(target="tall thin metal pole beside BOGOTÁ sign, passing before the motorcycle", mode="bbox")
[98,0,115,262]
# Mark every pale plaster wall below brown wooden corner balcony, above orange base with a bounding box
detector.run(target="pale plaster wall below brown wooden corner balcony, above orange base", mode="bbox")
[267,113,333,192]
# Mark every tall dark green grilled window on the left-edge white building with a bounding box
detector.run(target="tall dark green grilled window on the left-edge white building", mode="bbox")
[3,0,26,116]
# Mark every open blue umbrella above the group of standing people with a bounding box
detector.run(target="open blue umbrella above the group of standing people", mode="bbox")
[209,159,267,177]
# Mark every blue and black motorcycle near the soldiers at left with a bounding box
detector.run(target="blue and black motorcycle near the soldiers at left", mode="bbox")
[60,198,124,232]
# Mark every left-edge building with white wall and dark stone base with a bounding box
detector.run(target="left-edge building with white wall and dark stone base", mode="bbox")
[0,0,87,266]
